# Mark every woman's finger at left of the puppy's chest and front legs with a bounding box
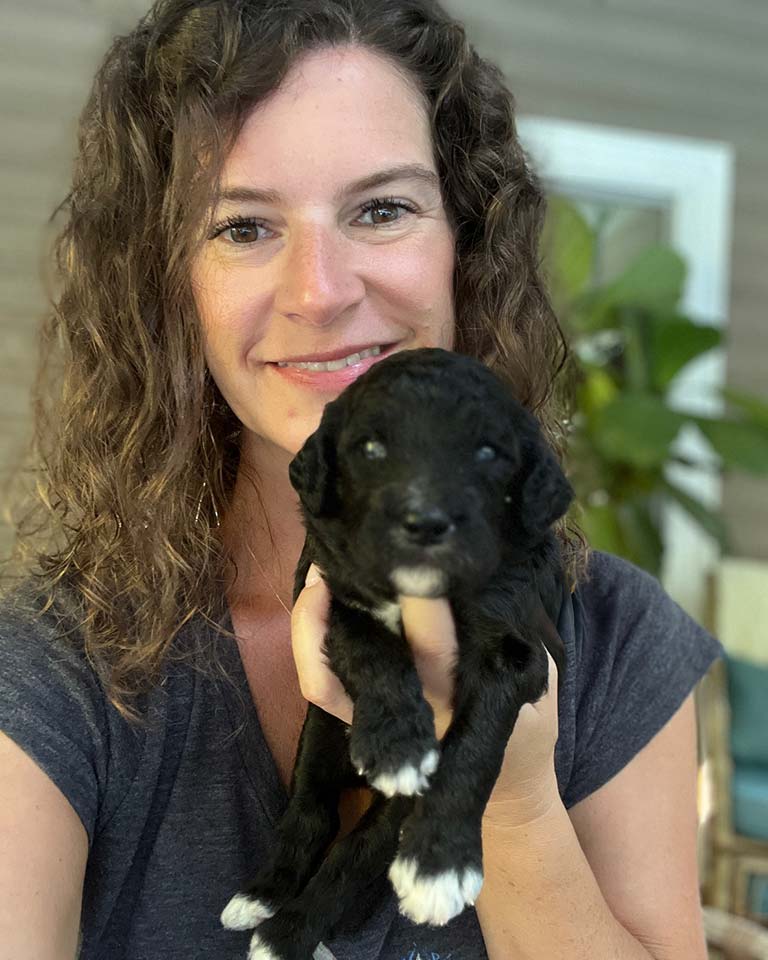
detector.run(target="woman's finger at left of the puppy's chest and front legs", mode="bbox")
[291,564,352,723]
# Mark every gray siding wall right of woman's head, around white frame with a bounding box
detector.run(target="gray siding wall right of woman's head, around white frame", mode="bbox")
[445,0,768,559]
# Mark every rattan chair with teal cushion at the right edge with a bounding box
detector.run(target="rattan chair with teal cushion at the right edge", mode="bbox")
[701,656,768,922]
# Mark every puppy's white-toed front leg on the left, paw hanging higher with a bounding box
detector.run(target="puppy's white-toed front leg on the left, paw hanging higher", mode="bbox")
[326,605,440,797]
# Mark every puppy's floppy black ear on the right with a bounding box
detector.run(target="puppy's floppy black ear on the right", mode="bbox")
[520,434,573,537]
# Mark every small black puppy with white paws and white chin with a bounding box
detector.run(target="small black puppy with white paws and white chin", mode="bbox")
[222,349,573,960]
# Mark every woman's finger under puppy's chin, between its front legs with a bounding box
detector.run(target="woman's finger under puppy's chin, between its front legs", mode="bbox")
[398,596,458,703]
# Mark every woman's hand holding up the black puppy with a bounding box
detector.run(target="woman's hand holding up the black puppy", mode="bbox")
[291,565,558,826]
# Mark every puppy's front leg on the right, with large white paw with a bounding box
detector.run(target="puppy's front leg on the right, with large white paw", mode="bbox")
[389,638,548,926]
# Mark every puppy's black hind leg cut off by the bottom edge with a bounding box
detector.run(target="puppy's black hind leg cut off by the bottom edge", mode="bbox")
[248,796,413,960]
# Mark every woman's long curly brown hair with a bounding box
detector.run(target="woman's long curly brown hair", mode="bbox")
[1,0,587,720]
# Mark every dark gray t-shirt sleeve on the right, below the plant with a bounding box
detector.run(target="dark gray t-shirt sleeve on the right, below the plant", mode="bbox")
[564,551,723,807]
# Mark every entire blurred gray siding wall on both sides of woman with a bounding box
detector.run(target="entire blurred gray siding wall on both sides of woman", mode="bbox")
[0,0,768,559]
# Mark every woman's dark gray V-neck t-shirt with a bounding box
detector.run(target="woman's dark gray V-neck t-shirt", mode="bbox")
[0,552,721,960]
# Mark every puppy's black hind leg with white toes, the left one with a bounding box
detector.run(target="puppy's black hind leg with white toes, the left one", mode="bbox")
[221,704,359,930]
